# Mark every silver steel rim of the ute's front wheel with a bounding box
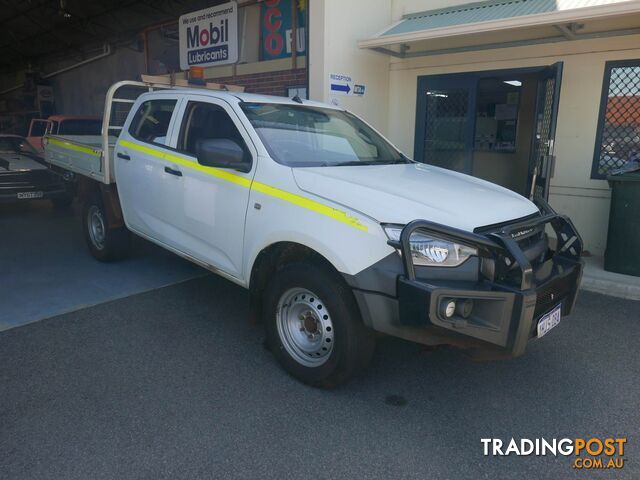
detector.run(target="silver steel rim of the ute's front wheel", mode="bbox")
[276,288,334,367]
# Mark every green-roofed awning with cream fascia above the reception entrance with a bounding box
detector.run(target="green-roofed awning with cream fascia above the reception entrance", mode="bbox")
[359,0,640,58]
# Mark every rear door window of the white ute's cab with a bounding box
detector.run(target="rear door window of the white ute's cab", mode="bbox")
[129,99,176,145]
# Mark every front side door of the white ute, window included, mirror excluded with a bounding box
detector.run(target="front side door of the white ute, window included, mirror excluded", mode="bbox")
[163,95,257,278]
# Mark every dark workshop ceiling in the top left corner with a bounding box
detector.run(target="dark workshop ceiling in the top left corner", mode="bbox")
[0,0,226,72]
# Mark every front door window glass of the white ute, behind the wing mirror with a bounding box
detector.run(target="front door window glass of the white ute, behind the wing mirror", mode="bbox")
[178,102,250,158]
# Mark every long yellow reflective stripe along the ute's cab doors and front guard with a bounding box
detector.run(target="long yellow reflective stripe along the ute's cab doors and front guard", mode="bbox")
[120,140,369,232]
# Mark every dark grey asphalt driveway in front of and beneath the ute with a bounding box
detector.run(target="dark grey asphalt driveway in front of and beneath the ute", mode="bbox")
[0,276,640,480]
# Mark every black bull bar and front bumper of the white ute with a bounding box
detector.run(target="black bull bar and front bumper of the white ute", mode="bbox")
[356,201,583,358]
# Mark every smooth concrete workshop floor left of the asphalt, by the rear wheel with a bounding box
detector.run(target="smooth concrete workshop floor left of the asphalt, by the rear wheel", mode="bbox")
[0,201,206,331]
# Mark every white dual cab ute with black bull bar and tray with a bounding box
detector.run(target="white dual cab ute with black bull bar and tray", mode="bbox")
[45,78,582,387]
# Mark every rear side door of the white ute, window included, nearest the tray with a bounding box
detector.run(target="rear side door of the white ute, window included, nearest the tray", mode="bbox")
[114,93,180,243]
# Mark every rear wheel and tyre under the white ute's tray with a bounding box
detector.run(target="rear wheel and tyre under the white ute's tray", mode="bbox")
[82,194,131,262]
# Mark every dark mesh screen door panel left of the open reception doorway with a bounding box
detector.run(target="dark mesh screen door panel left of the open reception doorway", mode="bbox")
[415,76,478,174]
